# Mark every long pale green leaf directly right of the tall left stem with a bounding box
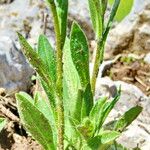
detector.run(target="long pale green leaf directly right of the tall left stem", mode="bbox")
[63,39,82,142]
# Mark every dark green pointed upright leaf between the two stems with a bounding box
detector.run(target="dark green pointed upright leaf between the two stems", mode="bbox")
[70,23,90,88]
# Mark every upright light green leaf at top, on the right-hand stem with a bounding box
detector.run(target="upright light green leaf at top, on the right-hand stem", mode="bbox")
[88,0,104,38]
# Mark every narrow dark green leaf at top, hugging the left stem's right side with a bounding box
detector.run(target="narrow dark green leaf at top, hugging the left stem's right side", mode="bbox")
[56,0,68,48]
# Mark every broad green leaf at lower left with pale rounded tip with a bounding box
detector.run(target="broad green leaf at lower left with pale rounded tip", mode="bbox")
[16,93,56,150]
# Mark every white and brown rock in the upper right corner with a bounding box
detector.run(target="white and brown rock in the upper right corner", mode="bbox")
[105,0,150,59]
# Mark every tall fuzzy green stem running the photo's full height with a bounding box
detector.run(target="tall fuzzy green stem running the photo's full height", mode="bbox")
[50,0,64,150]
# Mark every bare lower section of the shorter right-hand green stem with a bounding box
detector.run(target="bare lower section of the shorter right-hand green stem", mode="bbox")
[91,40,104,95]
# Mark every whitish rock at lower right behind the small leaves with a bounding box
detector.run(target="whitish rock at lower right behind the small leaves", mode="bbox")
[95,77,150,150]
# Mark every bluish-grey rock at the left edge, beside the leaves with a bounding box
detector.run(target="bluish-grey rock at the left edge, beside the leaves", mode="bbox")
[0,36,33,95]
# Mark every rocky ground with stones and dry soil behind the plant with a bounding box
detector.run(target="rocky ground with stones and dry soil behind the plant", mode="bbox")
[0,0,150,150]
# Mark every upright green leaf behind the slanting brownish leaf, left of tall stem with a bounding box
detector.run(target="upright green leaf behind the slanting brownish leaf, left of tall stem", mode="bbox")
[38,35,56,84]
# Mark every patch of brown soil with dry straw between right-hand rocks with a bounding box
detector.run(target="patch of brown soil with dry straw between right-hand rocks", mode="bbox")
[106,54,150,96]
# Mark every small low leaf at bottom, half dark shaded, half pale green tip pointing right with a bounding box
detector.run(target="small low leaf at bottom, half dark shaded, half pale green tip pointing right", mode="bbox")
[88,131,120,150]
